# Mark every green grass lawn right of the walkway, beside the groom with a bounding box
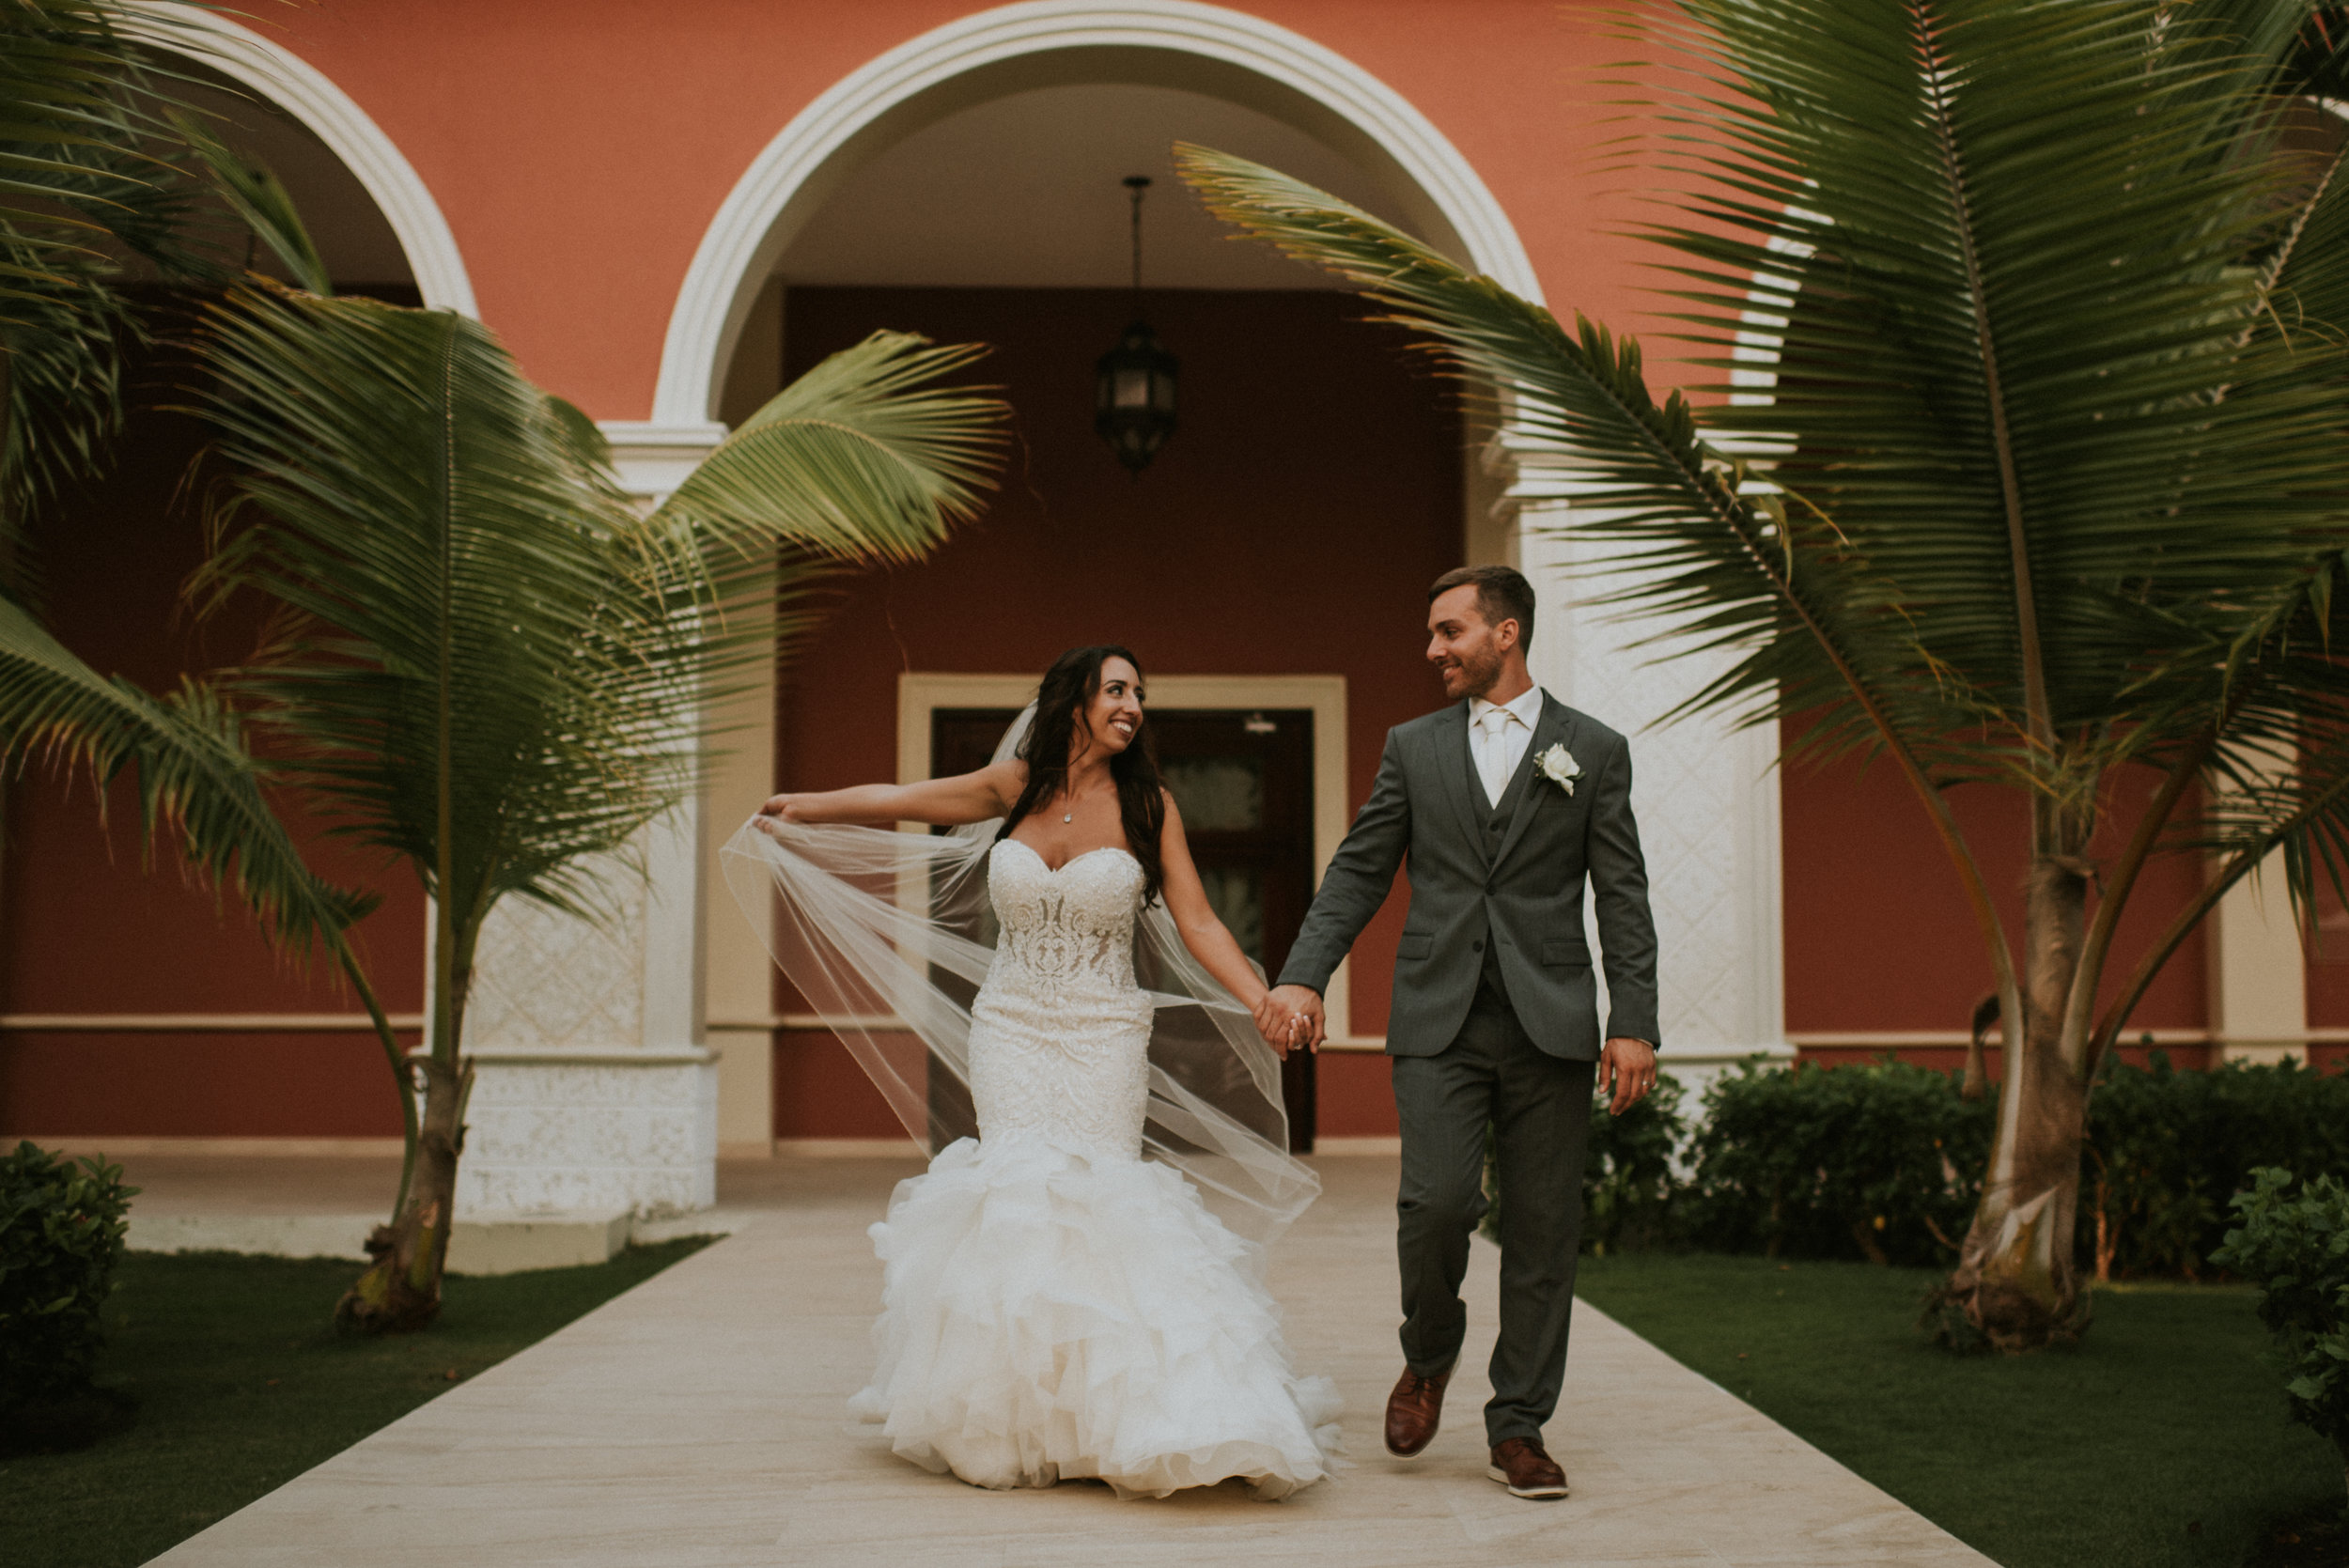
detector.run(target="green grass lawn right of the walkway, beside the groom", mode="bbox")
[1567,1253,2344,1568]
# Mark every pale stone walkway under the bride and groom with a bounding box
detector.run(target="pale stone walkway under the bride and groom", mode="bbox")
[158,1157,1990,1568]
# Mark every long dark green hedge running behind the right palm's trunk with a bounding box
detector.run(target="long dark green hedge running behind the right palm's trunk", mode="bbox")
[1487,1051,2349,1280]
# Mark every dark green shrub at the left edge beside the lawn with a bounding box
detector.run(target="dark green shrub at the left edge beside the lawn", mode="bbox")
[0,1143,139,1408]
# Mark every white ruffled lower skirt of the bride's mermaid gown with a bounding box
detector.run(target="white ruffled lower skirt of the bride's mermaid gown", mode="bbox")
[853,1139,1339,1500]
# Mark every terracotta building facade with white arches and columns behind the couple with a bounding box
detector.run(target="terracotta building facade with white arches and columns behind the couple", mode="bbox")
[0,0,2349,1214]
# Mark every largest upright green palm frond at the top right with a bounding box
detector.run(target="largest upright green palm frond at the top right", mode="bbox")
[1658,0,2344,737]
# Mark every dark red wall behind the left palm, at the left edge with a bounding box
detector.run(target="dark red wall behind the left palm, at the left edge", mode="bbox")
[0,378,423,1136]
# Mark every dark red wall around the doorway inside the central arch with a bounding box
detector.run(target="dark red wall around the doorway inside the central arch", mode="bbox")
[775,288,1461,1136]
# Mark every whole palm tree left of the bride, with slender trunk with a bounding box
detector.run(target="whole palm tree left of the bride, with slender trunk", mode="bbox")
[200,287,1001,1328]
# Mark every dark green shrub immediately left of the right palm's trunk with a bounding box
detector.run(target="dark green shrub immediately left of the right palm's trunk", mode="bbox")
[1689,1059,1992,1263]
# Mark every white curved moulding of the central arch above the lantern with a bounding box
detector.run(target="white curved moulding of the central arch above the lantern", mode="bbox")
[628,0,1541,431]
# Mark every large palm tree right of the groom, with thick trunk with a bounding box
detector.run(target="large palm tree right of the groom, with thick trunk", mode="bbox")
[1182,0,2349,1347]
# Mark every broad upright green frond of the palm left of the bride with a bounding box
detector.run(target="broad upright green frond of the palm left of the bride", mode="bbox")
[202,287,684,923]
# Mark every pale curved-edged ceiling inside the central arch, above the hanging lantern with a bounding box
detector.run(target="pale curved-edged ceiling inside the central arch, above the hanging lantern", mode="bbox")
[775,85,1400,288]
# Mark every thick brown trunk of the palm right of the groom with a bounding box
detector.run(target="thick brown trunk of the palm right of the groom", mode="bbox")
[1936,854,2091,1350]
